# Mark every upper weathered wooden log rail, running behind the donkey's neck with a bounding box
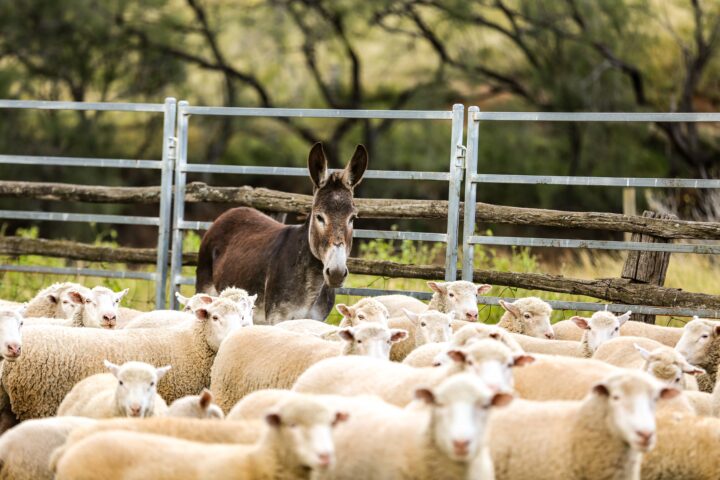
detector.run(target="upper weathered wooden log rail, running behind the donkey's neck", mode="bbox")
[0,181,720,240]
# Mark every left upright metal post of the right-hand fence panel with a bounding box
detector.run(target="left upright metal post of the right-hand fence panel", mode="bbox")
[462,107,480,282]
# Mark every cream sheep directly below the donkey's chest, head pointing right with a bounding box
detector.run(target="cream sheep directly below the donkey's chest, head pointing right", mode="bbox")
[210,323,407,412]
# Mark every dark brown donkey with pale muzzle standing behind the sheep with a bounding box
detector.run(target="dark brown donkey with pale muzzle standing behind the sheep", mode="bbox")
[196,143,368,325]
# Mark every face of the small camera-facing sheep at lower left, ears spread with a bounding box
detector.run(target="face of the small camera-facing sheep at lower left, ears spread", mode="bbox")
[105,360,170,417]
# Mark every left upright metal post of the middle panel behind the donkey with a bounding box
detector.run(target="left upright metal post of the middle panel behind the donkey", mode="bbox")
[170,101,190,310]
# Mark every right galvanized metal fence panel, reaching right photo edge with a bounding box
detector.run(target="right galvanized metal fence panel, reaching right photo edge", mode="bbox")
[462,106,720,318]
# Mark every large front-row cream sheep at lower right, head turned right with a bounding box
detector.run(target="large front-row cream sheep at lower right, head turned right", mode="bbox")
[489,370,679,480]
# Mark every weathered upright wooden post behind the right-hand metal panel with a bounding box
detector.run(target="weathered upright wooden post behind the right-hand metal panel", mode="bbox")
[622,210,677,323]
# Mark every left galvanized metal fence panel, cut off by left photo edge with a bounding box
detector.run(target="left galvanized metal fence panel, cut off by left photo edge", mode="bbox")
[0,98,177,308]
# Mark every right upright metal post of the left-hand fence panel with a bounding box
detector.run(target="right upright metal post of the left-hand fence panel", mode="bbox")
[155,97,177,310]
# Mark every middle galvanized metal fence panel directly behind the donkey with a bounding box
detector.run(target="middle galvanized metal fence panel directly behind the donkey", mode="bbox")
[170,101,465,307]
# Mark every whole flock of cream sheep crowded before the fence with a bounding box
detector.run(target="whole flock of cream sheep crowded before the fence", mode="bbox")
[0,281,720,480]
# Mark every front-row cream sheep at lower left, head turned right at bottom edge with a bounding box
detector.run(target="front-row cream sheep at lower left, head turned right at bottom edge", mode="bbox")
[52,398,348,480]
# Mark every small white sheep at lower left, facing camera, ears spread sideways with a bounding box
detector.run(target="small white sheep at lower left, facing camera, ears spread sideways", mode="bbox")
[57,360,170,418]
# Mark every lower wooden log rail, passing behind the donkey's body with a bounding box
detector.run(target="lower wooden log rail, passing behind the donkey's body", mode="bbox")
[0,237,720,309]
